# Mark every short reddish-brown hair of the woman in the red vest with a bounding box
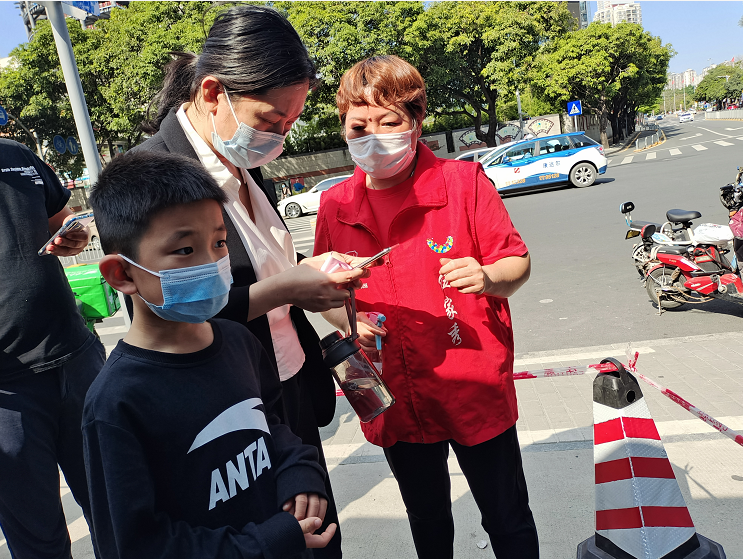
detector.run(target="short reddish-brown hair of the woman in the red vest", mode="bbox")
[335,55,426,131]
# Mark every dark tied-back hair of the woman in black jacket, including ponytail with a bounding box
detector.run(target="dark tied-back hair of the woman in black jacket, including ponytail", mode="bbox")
[142,5,316,134]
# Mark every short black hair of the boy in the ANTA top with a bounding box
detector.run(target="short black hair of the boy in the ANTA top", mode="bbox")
[90,151,227,259]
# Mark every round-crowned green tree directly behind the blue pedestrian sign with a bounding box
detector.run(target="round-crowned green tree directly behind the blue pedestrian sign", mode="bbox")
[532,23,675,146]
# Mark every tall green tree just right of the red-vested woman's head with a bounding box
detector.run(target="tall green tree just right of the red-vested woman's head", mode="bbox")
[405,2,575,146]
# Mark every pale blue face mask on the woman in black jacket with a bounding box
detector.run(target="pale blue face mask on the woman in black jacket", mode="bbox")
[211,90,288,169]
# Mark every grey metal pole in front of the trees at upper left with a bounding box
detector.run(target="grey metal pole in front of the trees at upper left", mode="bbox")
[42,2,101,184]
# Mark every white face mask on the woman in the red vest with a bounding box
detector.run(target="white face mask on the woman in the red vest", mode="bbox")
[347,129,415,179]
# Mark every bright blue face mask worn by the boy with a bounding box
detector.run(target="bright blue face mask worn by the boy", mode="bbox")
[119,254,232,324]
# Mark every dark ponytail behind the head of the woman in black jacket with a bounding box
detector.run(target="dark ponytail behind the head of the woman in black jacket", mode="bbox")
[141,52,199,134]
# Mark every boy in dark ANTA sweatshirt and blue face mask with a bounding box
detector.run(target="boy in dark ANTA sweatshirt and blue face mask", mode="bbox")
[83,152,336,559]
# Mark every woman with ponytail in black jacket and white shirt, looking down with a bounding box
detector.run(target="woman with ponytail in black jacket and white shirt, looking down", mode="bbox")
[135,5,365,558]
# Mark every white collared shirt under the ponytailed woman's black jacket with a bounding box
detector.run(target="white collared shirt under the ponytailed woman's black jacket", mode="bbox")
[177,103,305,382]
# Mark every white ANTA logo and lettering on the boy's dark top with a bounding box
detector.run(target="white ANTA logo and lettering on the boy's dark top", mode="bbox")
[188,398,271,510]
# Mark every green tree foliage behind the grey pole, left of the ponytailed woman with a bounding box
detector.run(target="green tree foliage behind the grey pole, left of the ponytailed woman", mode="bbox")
[0,2,218,177]
